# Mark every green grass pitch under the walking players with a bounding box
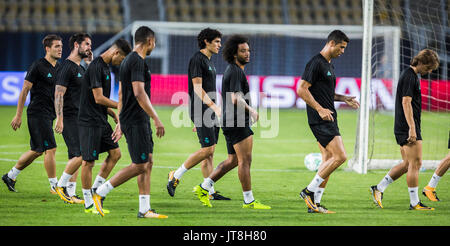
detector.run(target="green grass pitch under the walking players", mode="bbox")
[0,107,450,226]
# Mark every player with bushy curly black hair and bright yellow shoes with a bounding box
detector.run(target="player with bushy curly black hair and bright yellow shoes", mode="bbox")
[194,35,271,209]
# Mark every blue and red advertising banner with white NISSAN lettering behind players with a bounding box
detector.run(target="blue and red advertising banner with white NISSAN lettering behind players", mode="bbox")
[0,72,450,110]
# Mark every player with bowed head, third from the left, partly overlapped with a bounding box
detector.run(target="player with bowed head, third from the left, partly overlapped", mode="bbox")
[57,39,131,213]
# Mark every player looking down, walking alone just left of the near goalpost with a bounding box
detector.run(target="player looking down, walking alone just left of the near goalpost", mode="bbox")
[297,30,359,213]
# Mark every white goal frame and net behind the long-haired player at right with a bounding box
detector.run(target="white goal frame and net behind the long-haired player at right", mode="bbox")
[349,0,450,173]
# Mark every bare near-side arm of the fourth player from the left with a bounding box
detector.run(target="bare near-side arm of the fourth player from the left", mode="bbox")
[132,81,165,138]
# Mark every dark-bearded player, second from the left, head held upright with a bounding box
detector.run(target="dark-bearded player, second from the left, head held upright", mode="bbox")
[55,33,91,204]
